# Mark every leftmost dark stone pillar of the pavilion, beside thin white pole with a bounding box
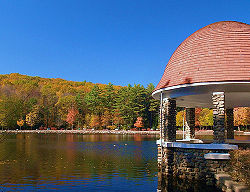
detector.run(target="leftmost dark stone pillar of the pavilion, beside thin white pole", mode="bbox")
[162,99,176,142]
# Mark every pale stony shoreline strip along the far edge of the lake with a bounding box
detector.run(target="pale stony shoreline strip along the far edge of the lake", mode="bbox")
[0,129,250,136]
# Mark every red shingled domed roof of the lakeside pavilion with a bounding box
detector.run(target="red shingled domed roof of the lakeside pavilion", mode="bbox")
[155,21,250,91]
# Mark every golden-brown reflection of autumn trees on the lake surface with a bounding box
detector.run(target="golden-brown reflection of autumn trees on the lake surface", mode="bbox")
[0,134,157,188]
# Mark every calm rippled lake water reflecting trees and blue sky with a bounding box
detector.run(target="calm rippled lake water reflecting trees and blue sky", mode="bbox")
[0,134,158,191]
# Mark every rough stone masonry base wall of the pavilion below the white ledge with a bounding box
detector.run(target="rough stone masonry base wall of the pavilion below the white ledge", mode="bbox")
[158,146,229,185]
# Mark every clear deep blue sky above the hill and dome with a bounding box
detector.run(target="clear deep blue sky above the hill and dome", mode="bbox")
[0,0,250,86]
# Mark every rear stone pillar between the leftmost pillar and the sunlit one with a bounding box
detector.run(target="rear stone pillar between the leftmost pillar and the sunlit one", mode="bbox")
[186,108,195,139]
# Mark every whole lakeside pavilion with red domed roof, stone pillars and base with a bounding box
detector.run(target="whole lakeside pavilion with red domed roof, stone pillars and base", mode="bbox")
[153,21,250,190]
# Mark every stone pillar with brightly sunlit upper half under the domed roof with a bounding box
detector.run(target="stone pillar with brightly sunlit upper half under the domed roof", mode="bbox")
[212,92,225,143]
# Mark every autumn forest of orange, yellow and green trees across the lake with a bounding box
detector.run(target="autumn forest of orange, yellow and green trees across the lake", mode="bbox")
[0,73,250,129]
